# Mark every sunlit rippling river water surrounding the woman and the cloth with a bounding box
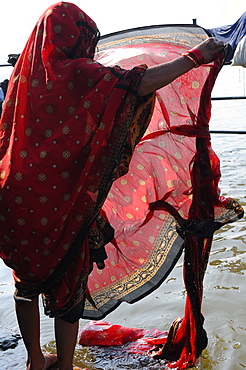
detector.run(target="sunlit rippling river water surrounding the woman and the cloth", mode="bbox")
[0,66,246,370]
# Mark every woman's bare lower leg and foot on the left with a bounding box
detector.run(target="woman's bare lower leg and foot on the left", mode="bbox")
[15,297,56,370]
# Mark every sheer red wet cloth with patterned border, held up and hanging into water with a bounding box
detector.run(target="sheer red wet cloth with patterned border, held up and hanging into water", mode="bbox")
[81,26,243,369]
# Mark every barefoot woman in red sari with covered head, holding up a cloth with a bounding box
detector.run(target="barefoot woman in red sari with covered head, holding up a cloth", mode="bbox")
[0,2,223,370]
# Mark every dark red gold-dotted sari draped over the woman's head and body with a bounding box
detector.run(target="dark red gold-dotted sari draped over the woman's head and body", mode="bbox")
[0,2,152,313]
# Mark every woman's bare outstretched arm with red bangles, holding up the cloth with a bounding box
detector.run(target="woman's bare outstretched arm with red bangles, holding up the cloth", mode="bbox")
[138,37,224,96]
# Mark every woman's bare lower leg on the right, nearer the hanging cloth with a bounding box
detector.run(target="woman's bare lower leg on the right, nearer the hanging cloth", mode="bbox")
[55,317,79,370]
